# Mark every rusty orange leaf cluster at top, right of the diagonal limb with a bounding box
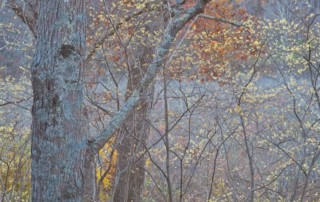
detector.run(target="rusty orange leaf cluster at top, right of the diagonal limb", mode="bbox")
[171,0,261,81]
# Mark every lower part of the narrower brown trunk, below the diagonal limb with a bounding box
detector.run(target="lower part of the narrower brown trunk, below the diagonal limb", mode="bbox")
[114,97,149,202]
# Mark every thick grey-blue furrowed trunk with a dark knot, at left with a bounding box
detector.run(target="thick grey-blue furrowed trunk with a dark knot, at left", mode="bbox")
[31,0,95,201]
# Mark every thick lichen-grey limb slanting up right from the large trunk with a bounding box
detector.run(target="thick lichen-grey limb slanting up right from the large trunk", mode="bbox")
[87,0,210,152]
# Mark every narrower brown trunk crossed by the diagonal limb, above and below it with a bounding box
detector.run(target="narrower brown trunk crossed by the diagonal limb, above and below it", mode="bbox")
[113,45,153,202]
